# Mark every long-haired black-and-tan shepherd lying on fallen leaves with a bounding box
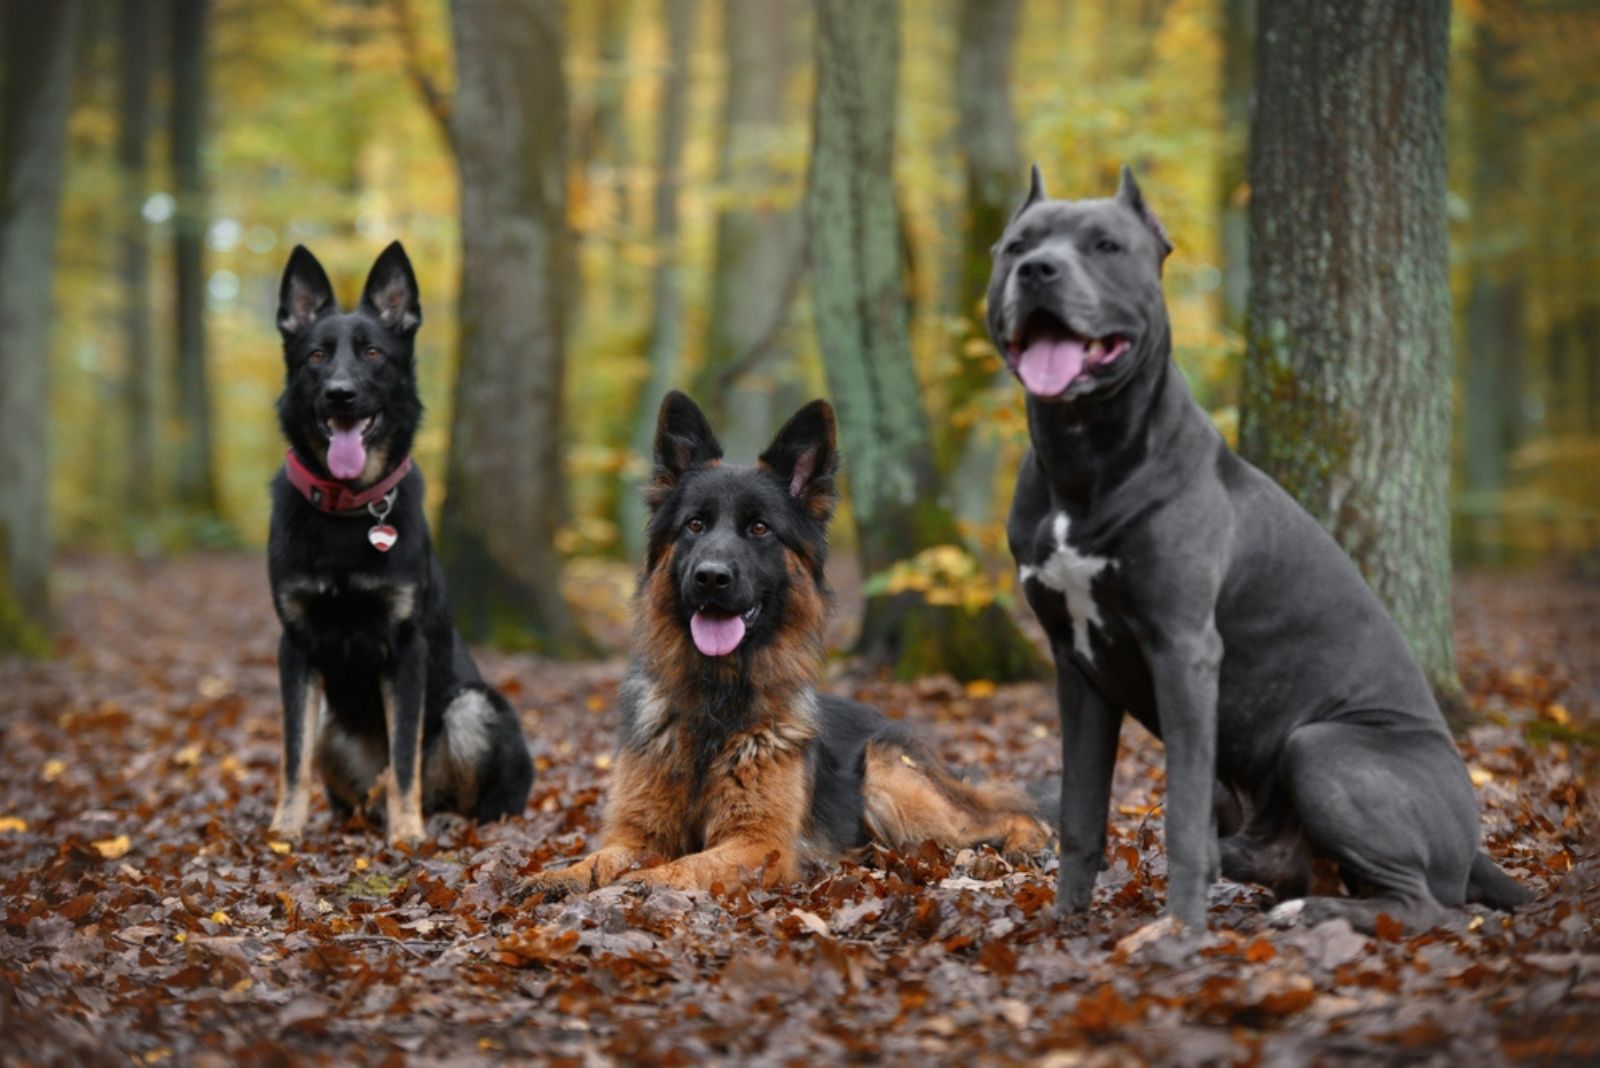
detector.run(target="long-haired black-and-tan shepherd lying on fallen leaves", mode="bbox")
[530,393,1048,895]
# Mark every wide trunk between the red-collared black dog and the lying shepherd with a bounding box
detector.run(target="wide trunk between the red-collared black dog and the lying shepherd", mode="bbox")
[440,0,589,656]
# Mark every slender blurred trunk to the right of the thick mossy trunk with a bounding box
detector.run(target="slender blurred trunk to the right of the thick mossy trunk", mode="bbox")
[1462,8,1526,507]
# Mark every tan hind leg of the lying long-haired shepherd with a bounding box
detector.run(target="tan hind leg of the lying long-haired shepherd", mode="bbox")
[862,742,1050,854]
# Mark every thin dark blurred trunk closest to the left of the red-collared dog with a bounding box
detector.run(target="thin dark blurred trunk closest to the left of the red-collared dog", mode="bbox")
[171,0,218,516]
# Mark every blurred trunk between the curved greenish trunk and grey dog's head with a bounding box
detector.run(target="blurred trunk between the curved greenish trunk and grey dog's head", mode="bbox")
[942,0,1022,521]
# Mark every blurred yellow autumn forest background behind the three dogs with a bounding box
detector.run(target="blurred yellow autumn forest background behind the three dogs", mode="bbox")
[0,0,1600,678]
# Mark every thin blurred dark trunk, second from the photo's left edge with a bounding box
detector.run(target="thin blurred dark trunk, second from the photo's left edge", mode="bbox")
[117,3,160,520]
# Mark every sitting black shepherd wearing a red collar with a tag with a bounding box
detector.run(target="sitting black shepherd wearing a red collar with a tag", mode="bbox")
[267,241,533,843]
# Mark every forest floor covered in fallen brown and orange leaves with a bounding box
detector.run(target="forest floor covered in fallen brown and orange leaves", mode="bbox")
[0,556,1600,1068]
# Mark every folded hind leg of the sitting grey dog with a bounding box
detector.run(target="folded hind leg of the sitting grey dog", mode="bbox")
[1282,715,1478,932]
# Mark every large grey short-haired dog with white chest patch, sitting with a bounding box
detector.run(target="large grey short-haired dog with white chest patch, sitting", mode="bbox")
[989,166,1528,931]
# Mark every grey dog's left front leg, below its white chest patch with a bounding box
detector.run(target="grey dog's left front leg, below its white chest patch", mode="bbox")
[1054,655,1122,916]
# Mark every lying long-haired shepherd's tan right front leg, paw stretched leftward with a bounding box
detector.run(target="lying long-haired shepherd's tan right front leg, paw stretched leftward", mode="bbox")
[629,727,811,891]
